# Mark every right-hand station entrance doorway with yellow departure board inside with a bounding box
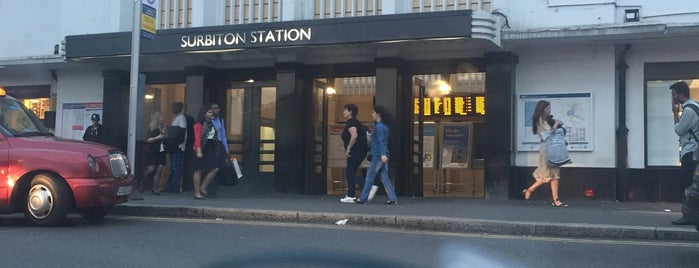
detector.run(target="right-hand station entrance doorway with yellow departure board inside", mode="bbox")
[411,73,485,198]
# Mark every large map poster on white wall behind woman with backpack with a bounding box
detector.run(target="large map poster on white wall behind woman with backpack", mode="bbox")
[516,92,594,151]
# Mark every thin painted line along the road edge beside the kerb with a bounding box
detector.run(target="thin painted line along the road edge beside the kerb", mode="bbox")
[112,216,699,248]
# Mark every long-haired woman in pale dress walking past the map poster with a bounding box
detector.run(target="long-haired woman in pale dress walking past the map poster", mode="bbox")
[522,100,568,208]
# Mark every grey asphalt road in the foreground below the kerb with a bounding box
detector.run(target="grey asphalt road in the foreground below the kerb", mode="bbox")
[0,216,699,267]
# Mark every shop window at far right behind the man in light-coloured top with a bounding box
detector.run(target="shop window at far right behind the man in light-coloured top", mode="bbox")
[646,78,699,166]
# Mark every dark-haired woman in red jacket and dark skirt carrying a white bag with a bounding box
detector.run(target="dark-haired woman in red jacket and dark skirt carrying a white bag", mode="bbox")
[192,107,225,199]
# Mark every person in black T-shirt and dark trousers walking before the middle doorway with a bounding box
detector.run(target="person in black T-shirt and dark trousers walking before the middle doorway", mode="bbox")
[340,103,379,203]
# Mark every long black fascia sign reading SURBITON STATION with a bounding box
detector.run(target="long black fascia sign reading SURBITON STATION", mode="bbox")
[66,10,471,59]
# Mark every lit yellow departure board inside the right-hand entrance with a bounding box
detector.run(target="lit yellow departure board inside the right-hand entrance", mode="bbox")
[413,94,485,116]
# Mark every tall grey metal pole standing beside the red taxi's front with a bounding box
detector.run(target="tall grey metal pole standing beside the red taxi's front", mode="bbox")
[126,0,141,175]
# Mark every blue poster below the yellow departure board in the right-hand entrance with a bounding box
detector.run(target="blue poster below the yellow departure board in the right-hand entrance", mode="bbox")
[442,124,470,168]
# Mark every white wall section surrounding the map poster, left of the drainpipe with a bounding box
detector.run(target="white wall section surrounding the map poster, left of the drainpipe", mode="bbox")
[513,44,615,167]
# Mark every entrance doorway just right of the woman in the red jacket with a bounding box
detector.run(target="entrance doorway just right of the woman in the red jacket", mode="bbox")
[225,81,277,193]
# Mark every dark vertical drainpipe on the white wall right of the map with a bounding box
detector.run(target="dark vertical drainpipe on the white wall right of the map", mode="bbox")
[615,44,631,202]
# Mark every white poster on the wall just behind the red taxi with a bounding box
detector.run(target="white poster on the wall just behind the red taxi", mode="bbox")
[61,102,103,140]
